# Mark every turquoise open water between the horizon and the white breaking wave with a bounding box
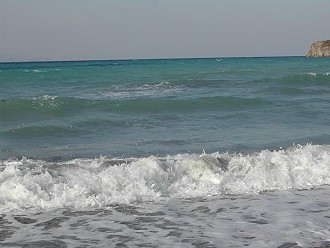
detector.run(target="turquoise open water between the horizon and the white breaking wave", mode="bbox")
[0,57,330,160]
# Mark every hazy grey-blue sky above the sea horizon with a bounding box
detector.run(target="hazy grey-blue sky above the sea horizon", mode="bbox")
[0,0,330,61]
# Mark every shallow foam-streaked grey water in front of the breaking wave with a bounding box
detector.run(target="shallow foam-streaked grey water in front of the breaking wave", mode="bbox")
[0,187,330,247]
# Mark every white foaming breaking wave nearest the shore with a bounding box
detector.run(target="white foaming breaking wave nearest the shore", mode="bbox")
[0,145,330,213]
